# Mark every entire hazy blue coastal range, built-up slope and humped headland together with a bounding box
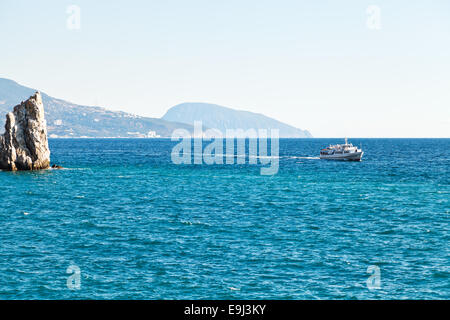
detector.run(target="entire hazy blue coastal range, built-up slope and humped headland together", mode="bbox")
[0,78,311,138]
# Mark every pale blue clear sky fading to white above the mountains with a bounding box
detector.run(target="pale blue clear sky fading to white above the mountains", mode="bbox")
[0,0,450,138]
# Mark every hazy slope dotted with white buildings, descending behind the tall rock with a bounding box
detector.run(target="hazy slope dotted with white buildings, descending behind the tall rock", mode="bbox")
[0,78,192,138]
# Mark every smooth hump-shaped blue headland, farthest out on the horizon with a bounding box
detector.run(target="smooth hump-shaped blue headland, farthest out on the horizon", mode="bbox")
[162,103,312,138]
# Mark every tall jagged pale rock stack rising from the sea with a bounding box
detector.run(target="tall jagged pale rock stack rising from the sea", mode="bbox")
[0,92,50,171]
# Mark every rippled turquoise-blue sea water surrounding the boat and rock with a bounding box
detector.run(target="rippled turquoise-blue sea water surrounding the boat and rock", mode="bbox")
[0,139,450,299]
